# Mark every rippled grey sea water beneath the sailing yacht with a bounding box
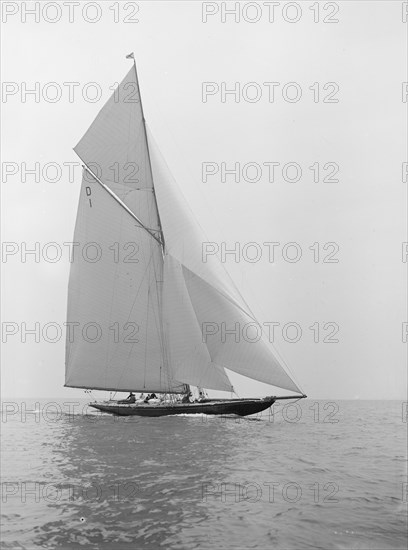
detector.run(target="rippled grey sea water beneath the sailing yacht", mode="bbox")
[2,400,407,550]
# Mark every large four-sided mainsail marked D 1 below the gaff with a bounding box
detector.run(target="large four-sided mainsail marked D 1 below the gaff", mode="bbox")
[66,173,183,392]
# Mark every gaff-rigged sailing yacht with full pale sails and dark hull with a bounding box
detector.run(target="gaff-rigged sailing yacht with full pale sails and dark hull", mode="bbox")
[65,54,306,416]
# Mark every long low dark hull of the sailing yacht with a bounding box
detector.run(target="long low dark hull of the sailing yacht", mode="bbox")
[89,397,276,416]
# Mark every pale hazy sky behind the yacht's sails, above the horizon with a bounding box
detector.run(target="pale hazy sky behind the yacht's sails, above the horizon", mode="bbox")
[2,1,408,399]
